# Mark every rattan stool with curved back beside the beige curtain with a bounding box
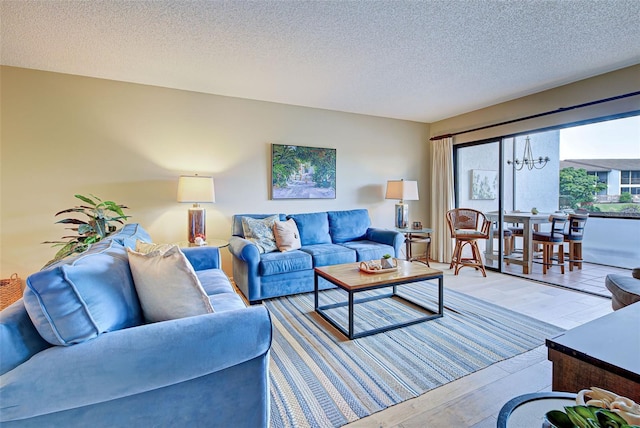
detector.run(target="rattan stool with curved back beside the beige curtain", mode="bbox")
[447,208,491,277]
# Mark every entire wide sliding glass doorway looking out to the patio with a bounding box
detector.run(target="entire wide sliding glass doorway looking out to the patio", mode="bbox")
[454,116,640,282]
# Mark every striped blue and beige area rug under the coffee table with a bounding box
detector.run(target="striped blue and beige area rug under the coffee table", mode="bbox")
[265,282,563,428]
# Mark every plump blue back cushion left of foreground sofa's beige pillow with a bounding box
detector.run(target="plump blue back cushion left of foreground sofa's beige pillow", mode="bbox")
[24,239,142,346]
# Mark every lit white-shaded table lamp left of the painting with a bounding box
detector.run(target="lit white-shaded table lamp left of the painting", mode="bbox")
[178,175,216,244]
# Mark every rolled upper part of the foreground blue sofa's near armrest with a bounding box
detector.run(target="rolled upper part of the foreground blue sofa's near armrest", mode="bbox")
[0,306,272,422]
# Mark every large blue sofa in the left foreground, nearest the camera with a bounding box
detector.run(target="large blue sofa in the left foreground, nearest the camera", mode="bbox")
[0,224,271,428]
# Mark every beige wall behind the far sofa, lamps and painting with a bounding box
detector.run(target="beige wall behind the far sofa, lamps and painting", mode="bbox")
[0,67,430,278]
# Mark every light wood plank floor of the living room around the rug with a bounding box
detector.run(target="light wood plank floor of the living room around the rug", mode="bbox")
[346,263,612,428]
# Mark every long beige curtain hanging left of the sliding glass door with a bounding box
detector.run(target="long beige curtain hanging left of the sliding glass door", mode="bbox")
[431,137,455,263]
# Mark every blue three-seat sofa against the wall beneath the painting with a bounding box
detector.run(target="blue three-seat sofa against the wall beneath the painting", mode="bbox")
[229,209,404,304]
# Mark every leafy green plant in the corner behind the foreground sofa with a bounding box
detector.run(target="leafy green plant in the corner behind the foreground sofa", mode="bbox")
[43,195,131,267]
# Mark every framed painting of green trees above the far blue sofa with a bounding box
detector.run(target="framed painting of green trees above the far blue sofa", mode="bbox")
[271,144,336,199]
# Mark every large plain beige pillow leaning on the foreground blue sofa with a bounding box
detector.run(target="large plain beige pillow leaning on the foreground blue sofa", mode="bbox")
[127,245,213,322]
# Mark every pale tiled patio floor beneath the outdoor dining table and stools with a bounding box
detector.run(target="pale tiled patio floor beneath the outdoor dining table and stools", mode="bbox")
[503,263,631,297]
